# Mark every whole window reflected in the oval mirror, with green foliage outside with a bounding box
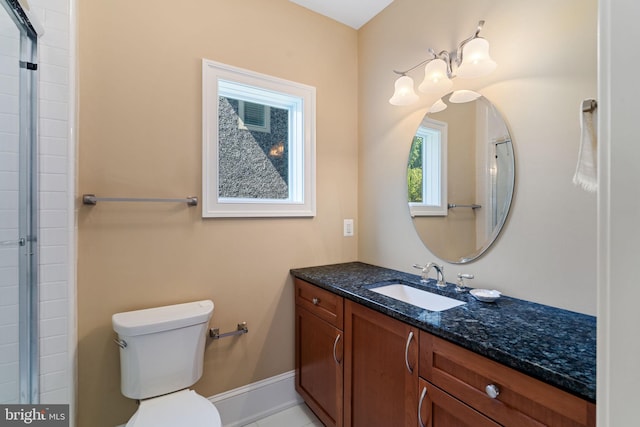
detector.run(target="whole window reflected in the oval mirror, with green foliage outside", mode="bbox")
[407,118,448,216]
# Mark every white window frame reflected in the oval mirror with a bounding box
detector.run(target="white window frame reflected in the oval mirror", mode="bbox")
[409,118,449,217]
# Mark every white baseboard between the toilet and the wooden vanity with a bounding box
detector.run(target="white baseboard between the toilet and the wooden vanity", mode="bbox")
[209,371,302,427]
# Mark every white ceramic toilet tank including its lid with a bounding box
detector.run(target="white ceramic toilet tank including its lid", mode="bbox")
[112,300,213,399]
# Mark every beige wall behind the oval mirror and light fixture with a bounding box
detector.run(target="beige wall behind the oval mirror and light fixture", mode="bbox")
[358,0,597,314]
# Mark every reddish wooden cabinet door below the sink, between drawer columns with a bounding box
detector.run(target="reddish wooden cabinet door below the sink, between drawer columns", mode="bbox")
[344,301,418,427]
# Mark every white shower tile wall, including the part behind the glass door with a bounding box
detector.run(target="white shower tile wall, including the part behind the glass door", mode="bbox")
[0,0,75,414]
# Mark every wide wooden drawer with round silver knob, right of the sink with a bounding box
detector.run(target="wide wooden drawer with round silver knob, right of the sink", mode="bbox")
[419,331,595,427]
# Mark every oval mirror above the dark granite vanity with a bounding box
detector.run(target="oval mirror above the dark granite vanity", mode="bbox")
[407,91,515,264]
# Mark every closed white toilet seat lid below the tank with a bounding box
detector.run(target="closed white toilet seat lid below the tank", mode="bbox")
[126,389,222,427]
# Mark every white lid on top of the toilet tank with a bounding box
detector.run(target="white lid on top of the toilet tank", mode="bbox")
[111,300,213,337]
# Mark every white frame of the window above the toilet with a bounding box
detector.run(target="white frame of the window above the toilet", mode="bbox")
[202,59,316,218]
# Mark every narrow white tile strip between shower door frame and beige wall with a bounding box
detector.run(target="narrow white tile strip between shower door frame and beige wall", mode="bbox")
[30,0,75,410]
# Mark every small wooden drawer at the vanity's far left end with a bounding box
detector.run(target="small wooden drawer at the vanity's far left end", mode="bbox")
[295,279,344,329]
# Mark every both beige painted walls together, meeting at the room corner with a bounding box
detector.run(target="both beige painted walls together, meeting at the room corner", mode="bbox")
[78,0,596,426]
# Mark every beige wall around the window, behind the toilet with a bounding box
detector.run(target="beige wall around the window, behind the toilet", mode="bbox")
[78,0,357,426]
